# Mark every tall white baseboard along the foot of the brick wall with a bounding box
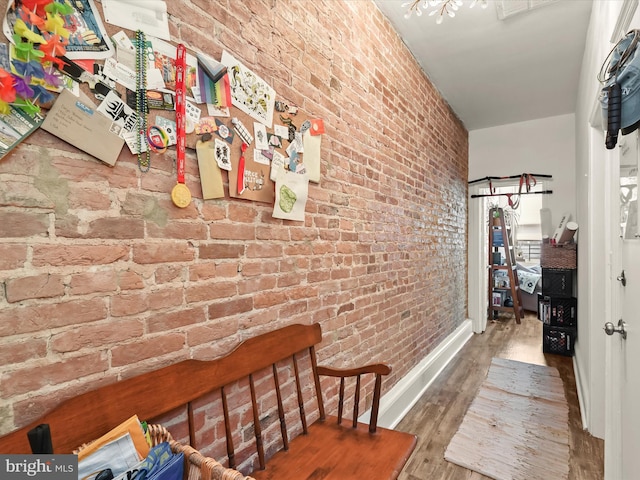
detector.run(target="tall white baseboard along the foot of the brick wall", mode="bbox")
[359,320,473,428]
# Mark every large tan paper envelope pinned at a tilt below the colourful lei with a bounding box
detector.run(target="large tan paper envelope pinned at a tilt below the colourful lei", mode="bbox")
[42,90,124,167]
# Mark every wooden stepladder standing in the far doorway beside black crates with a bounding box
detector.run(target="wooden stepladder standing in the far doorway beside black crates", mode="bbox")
[487,207,524,323]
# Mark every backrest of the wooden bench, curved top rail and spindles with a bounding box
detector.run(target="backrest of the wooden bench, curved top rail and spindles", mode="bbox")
[0,324,324,462]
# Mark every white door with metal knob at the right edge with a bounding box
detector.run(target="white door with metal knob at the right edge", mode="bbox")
[605,129,640,480]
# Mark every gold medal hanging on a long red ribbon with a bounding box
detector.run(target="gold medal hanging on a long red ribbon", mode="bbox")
[171,43,191,208]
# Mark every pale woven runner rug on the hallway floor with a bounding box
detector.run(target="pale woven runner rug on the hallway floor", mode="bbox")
[444,358,569,480]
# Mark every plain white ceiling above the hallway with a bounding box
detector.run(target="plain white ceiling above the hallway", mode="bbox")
[374,0,597,131]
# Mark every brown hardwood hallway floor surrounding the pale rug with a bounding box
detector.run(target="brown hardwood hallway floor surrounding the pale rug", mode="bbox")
[396,313,604,480]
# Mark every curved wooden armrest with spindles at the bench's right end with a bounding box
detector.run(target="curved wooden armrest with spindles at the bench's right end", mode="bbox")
[317,363,391,433]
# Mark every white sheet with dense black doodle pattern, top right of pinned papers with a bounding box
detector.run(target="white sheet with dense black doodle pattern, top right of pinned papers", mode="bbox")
[221,50,276,128]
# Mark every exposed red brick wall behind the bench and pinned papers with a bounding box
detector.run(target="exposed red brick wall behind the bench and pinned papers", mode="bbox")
[0,0,468,466]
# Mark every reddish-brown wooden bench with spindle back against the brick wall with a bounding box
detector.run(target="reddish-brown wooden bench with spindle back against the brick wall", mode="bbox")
[0,324,416,480]
